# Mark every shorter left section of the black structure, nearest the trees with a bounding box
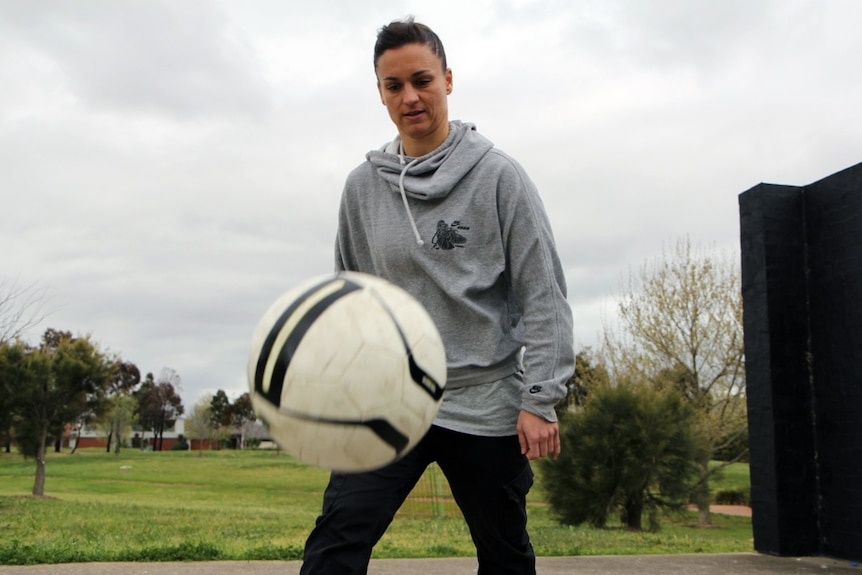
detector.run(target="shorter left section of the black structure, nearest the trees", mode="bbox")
[740,184,819,555]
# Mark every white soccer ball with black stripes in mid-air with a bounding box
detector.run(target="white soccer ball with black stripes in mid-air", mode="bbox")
[243,272,446,472]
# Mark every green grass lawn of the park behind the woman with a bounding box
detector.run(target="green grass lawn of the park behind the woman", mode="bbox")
[0,449,752,564]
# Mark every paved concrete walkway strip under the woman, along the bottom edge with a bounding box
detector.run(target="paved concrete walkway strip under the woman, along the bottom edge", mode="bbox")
[0,553,862,575]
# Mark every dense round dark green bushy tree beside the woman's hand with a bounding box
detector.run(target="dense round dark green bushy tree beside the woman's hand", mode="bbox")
[540,381,703,530]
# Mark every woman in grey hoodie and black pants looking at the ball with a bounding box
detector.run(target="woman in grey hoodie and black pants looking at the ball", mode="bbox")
[301,19,574,575]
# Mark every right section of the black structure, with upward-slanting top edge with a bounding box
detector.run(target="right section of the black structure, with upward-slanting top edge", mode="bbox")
[806,164,862,559]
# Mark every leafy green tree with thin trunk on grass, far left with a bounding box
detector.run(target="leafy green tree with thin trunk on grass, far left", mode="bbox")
[4,329,110,495]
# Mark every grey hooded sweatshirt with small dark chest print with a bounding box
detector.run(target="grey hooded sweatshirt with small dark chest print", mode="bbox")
[335,121,574,429]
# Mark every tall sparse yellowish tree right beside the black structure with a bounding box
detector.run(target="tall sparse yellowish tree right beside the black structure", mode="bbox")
[602,238,747,525]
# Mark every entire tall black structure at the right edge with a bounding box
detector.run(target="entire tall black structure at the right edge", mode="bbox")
[739,164,862,561]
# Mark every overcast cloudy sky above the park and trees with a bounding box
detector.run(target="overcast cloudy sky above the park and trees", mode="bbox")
[0,0,862,409]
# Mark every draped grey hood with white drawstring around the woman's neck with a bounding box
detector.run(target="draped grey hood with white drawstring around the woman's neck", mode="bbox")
[366,120,494,201]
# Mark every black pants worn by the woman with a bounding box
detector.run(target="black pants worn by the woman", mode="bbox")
[300,426,536,575]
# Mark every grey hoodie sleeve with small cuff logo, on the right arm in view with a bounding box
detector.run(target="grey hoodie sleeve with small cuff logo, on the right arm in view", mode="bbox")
[497,153,575,421]
